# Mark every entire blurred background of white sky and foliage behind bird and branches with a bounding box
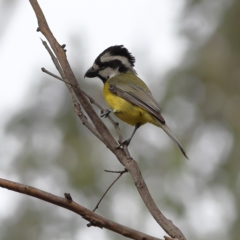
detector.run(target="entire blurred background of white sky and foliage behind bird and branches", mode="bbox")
[0,0,240,240]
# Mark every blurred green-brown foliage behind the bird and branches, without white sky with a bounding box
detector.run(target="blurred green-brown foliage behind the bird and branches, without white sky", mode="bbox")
[0,0,240,240]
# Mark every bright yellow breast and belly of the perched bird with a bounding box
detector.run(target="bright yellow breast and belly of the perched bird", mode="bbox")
[103,82,158,126]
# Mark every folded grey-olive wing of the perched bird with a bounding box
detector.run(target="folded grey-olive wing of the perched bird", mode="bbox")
[109,82,165,124]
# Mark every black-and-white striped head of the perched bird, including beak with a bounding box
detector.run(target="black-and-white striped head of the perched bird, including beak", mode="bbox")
[84,45,137,83]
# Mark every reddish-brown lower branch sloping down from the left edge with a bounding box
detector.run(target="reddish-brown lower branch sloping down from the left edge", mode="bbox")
[0,178,160,240]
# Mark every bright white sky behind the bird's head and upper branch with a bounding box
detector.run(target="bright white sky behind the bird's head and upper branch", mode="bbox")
[0,0,231,240]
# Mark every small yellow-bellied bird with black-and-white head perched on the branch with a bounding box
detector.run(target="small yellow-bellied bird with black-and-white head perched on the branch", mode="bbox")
[84,45,188,159]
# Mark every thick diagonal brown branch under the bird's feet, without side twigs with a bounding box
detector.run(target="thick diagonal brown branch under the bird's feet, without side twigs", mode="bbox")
[29,0,186,240]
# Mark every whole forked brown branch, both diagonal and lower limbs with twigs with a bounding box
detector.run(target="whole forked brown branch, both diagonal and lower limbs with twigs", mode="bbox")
[0,0,186,240]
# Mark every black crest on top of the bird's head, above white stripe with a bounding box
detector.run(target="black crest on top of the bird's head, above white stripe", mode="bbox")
[97,45,135,67]
